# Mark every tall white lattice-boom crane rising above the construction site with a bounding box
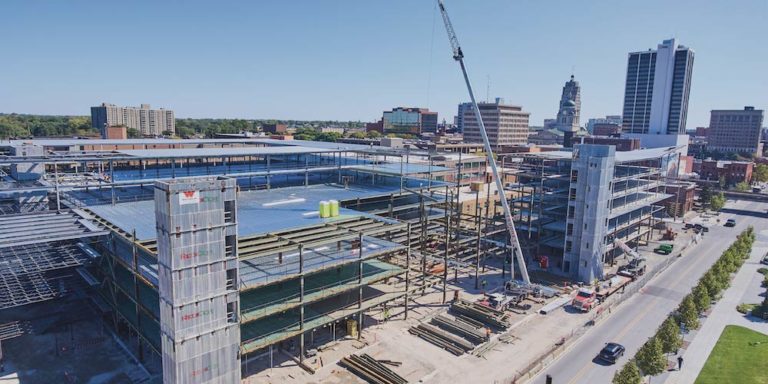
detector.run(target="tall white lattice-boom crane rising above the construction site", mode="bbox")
[437,0,531,284]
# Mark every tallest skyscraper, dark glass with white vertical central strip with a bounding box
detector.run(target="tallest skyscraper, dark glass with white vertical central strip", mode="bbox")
[622,39,694,135]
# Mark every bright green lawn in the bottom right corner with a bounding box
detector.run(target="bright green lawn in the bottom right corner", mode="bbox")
[696,325,768,384]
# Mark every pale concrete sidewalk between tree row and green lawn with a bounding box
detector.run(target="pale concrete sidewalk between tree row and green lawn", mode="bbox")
[660,234,768,384]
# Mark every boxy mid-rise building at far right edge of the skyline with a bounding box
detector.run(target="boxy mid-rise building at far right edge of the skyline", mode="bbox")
[707,107,763,156]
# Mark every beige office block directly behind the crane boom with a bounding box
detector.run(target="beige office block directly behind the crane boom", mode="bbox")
[463,98,530,148]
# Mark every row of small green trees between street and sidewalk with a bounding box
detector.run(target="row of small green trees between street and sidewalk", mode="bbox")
[613,227,755,384]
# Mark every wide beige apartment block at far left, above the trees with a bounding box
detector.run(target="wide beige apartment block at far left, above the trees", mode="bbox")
[91,103,176,138]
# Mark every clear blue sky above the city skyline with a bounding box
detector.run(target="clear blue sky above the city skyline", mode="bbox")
[0,0,768,128]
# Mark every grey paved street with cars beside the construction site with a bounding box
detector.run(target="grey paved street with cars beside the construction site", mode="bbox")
[531,201,768,384]
